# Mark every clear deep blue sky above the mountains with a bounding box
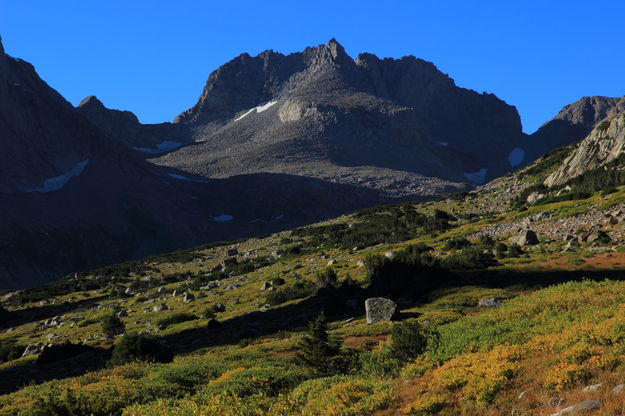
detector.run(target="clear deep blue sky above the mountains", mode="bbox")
[0,0,625,132]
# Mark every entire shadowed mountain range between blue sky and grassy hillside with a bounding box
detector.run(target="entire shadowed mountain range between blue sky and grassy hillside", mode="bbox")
[0,35,623,287]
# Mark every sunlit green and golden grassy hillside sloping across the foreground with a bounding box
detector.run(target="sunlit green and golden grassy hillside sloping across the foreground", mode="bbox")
[0,170,625,416]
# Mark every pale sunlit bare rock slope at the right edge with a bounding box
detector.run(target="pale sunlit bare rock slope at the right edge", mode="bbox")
[544,113,625,187]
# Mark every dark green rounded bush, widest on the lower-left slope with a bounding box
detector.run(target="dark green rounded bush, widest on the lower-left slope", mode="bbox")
[109,333,173,366]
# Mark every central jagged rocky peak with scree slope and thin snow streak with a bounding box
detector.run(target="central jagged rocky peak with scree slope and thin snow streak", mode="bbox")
[155,39,524,193]
